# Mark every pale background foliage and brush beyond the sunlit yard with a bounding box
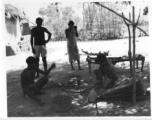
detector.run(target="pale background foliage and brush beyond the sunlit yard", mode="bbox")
[39,1,148,41]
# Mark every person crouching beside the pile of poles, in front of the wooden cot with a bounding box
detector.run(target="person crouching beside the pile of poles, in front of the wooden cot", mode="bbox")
[94,54,118,88]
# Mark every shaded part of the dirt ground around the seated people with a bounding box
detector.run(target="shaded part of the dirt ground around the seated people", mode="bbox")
[7,62,151,117]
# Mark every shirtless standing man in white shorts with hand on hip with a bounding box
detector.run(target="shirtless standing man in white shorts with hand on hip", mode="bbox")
[31,18,51,77]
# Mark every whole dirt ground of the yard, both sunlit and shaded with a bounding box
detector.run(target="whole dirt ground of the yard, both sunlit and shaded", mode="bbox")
[6,38,151,117]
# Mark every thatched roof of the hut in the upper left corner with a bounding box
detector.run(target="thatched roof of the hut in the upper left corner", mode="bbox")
[5,4,24,18]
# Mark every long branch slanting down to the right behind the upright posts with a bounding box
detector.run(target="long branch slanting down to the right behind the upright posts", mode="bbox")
[94,2,149,36]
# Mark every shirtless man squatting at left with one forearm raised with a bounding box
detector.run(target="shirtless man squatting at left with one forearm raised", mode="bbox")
[21,57,55,104]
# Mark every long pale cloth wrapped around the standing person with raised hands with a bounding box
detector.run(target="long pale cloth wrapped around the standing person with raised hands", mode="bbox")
[67,28,79,62]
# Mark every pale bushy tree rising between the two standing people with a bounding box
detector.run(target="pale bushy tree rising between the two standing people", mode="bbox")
[39,3,80,41]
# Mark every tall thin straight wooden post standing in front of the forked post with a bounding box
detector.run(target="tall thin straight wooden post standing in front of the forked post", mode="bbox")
[132,6,136,104]
